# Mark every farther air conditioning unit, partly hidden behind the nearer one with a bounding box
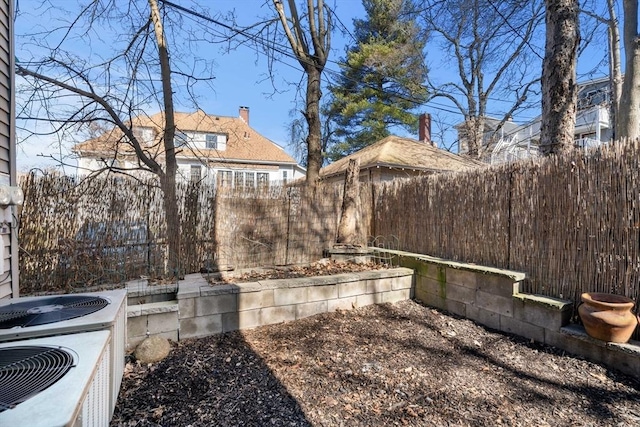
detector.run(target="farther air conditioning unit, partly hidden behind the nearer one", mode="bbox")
[0,289,127,420]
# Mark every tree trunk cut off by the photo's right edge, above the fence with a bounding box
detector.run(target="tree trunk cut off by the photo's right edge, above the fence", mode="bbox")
[616,0,640,139]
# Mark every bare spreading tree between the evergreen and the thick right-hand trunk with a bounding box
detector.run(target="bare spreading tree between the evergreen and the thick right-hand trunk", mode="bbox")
[418,0,543,157]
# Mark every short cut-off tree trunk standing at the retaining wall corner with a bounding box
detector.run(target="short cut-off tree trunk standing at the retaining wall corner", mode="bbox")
[336,159,360,245]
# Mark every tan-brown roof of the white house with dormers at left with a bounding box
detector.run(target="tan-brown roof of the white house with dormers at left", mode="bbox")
[73,110,297,164]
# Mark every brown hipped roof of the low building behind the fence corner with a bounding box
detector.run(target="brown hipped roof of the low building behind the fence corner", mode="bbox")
[320,135,486,178]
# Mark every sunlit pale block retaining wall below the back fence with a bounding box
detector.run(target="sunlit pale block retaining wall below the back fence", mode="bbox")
[127,268,413,348]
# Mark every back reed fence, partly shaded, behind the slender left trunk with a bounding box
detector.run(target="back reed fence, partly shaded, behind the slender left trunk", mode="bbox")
[19,175,370,294]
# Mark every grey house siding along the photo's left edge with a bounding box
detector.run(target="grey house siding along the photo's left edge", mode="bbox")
[0,0,18,298]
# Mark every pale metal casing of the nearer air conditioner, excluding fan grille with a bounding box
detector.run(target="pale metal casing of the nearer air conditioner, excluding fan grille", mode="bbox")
[0,330,112,427]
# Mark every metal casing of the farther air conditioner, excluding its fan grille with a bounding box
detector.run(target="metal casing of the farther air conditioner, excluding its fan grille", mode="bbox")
[0,289,127,425]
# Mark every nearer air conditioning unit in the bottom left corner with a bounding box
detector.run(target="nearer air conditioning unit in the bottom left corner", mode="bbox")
[0,331,111,427]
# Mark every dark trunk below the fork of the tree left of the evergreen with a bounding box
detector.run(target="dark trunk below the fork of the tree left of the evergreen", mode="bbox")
[305,65,322,186]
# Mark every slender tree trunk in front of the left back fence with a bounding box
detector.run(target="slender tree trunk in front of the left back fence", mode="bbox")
[148,0,183,277]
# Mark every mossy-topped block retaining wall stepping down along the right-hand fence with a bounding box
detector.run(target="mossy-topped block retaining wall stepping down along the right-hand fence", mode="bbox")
[376,249,640,378]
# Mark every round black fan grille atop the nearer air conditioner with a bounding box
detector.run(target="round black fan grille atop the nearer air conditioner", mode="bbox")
[0,346,74,412]
